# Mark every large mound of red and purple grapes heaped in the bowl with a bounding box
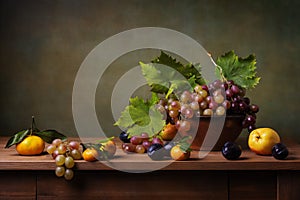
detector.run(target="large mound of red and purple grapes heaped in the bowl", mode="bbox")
[156,80,259,135]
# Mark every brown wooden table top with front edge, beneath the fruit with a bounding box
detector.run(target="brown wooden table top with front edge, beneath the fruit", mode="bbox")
[0,137,300,171]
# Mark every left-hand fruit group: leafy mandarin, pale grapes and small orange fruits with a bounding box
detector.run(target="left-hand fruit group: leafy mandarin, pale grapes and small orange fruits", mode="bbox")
[5,117,117,180]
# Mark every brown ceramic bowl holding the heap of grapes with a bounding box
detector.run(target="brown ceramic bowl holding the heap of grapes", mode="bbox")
[191,115,245,151]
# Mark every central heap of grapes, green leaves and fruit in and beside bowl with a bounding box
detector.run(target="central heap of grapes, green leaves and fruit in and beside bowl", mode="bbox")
[115,51,260,160]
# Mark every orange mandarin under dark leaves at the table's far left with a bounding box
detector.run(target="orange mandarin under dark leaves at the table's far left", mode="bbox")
[16,135,45,156]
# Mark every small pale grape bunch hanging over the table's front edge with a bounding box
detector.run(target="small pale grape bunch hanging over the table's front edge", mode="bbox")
[47,139,82,180]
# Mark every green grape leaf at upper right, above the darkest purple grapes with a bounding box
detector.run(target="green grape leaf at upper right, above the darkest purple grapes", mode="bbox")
[216,51,260,89]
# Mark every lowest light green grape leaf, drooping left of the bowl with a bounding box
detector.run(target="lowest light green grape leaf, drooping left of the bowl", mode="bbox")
[114,93,165,136]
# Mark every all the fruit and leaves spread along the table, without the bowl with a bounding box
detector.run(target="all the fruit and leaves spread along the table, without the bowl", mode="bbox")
[5,51,289,180]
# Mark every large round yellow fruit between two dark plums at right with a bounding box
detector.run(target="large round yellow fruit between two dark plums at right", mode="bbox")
[248,128,280,155]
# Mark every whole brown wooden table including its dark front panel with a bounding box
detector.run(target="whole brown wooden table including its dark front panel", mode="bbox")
[0,137,300,200]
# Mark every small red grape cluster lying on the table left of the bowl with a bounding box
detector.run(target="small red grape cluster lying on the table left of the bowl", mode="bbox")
[119,132,163,154]
